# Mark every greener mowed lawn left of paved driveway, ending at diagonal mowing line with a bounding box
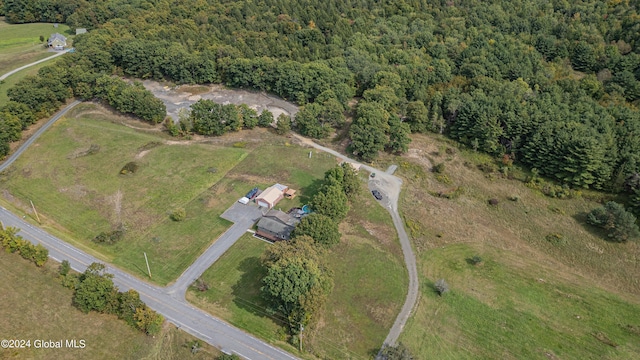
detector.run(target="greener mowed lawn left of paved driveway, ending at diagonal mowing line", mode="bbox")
[2,111,248,284]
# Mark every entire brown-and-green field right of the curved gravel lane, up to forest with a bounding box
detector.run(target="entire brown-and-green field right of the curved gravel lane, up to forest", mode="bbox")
[370,135,640,359]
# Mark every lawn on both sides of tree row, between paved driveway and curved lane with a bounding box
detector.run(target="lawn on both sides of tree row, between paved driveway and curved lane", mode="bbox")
[187,183,407,359]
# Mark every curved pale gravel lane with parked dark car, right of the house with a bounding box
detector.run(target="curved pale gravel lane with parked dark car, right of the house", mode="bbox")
[293,134,419,346]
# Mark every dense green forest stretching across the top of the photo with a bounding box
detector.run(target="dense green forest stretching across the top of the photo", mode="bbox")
[0,0,640,197]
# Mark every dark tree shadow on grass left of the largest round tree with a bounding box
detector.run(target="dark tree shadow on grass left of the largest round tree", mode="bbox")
[231,256,284,326]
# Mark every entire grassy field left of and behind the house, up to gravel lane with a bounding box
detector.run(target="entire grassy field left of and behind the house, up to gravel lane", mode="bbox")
[0,105,344,285]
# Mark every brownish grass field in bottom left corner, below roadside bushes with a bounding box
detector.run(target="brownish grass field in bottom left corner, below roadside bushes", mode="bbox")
[0,251,220,360]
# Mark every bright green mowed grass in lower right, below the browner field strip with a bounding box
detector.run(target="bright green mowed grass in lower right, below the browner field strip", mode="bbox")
[400,244,640,359]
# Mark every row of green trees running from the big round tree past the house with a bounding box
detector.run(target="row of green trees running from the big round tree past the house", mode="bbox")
[261,163,361,341]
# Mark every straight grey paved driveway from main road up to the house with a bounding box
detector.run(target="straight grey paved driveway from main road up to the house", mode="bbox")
[167,202,262,300]
